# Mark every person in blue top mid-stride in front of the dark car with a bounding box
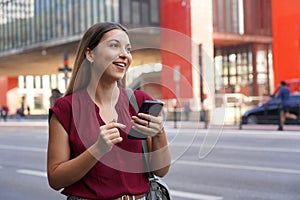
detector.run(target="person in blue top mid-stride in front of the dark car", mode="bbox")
[277,81,297,131]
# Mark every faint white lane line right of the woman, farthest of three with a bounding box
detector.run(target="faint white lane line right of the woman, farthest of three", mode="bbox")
[169,143,300,153]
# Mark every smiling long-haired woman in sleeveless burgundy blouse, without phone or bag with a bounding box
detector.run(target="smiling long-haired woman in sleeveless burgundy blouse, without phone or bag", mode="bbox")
[47,23,171,200]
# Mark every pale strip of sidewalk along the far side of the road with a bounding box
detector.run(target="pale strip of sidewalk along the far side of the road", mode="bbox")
[0,118,300,134]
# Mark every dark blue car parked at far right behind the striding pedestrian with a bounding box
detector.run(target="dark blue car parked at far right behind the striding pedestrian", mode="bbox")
[241,95,300,124]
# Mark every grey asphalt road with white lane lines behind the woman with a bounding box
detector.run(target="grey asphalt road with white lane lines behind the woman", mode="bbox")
[0,121,300,200]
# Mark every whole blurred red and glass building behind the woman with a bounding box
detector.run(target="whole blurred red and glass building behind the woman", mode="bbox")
[0,0,300,122]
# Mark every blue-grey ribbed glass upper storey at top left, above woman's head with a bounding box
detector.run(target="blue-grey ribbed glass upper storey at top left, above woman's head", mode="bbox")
[0,0,159,52]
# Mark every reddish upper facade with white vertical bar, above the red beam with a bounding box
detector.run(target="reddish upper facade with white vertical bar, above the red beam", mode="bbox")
[213,0,272,36]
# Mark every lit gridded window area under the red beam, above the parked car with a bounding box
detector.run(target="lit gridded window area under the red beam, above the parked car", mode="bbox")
[214,45,273,96]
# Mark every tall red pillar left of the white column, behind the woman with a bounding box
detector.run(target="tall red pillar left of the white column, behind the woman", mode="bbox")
[160,0,193,99]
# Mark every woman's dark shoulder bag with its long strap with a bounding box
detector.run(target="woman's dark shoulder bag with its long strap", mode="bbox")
[126,88,172,200]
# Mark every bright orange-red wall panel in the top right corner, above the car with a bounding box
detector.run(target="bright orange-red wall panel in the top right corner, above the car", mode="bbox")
[272,0,300,88]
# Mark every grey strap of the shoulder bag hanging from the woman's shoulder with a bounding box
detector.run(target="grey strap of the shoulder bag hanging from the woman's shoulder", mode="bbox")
[126,88,154,179]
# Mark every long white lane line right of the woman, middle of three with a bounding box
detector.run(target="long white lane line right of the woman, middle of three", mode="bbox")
[175,160,300,175]
